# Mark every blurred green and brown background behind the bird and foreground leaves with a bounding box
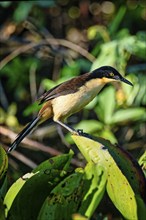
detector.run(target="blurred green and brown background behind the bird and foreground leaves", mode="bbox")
[0,0,146,181]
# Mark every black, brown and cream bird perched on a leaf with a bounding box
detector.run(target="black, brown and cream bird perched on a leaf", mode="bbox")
[7,66,133,153]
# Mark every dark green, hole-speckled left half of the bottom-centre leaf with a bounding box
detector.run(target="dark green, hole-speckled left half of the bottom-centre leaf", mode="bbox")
[37,170,84,220]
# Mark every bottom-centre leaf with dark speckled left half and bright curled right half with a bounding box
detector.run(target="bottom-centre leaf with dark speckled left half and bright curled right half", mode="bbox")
[38,162,106,220]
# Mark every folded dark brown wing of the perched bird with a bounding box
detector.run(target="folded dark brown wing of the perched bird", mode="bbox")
[38,73,89,104]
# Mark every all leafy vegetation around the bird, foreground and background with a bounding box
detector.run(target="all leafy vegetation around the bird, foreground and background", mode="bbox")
[0,0,146,220]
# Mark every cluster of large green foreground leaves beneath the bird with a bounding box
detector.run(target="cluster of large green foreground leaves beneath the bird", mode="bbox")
[1,135,146,220]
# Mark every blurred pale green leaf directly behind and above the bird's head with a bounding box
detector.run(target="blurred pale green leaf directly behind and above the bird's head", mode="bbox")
[91,32,146,72]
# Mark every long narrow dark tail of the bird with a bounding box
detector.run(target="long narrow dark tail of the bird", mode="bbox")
[7,117,40,153]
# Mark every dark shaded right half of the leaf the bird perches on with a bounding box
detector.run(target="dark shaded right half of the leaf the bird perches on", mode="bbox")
[96,138,146,208]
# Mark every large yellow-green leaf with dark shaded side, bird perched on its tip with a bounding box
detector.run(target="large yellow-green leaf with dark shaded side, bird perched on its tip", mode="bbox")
[72,135,145,219]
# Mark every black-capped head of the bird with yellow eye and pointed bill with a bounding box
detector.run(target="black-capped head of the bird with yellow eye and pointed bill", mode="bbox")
[91,66,133,86]
